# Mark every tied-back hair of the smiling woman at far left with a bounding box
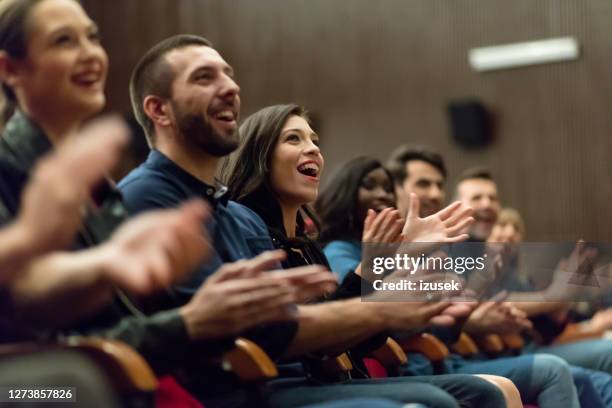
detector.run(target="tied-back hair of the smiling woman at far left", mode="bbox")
[0,0,42,123]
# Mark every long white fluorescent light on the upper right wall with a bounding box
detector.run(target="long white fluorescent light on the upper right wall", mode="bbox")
[469,37,580,71]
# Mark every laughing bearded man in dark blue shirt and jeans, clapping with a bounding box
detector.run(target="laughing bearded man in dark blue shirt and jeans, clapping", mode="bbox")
[119,36,504,406]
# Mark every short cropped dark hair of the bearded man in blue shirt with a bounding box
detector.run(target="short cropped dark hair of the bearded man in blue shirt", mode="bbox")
[130,34,213,146]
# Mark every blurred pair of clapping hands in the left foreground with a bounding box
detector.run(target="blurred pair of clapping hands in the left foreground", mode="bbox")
[0,116,210,294]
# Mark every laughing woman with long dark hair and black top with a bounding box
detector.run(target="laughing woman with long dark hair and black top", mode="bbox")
[226,104,524,406]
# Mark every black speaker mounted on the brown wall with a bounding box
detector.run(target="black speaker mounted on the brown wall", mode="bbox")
[447,99,493,147]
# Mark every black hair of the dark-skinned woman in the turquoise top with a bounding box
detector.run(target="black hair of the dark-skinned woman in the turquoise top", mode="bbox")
[315,157,393,243]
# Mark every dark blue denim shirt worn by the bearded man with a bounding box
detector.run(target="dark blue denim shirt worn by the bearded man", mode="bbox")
[119,150,297,358]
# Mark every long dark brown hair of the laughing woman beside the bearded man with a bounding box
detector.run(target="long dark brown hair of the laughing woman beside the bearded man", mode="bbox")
[223,104,318,237]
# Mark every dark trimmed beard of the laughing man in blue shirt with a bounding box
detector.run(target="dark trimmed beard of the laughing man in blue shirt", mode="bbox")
[174,105,239,157]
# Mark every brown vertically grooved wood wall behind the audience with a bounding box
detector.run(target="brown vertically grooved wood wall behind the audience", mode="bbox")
[83,0,612,241]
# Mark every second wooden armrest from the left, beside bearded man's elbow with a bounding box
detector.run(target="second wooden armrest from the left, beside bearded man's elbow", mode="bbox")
[222,338,278,381]
